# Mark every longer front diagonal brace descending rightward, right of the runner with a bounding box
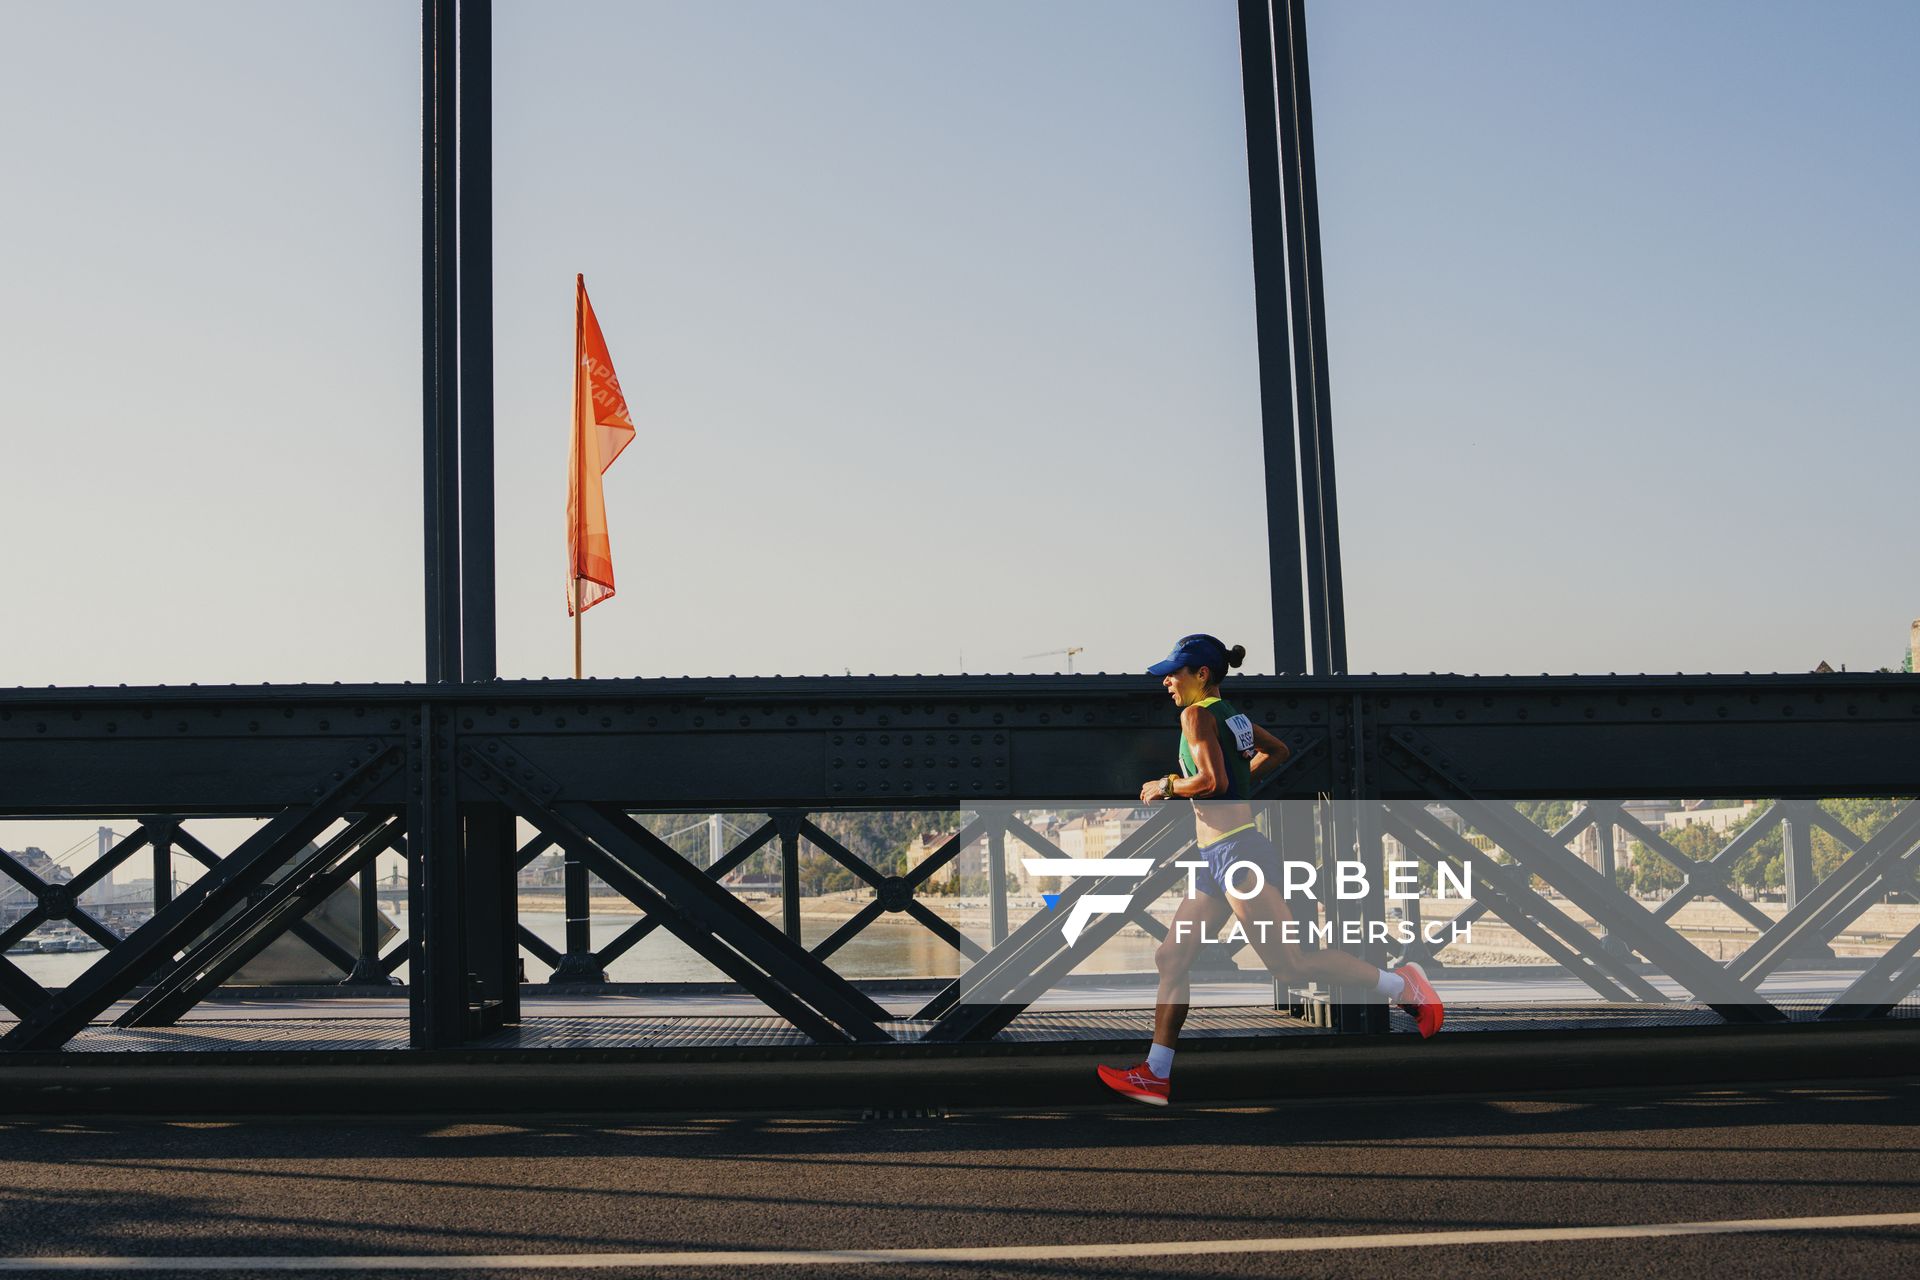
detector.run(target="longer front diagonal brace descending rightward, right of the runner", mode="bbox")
[1388,727,1786,1023]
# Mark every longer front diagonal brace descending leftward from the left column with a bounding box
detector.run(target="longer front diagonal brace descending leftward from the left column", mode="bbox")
[0,739,405,1050]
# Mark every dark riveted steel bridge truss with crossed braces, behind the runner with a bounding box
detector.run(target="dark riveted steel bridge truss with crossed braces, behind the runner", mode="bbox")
[0,676,1920,1050]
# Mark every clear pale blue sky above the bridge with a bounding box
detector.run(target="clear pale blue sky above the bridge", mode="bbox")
[0,0,1920,702]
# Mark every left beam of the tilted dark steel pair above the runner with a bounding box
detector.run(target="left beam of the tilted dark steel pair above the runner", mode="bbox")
[1240,0,1308,674]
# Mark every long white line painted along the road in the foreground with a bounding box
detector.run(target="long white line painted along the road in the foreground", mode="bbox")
[0,1213,1920,1272]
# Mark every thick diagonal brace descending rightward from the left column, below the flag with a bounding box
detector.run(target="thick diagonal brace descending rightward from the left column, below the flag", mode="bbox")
[459,743,893,1044]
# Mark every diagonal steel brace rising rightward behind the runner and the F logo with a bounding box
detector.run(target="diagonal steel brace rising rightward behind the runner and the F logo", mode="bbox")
[918,733,1327,1044]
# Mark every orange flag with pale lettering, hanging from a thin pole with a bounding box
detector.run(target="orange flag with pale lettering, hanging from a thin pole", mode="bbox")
[566,276,634,614]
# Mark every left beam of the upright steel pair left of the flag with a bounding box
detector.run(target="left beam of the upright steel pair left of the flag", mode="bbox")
[420,0,461,683]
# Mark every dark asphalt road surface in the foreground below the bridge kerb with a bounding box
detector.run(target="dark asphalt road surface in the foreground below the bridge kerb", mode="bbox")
[0,1079,1920,1280]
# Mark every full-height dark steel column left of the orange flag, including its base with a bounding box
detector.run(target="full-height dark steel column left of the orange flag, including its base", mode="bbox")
[407,0,520,1046]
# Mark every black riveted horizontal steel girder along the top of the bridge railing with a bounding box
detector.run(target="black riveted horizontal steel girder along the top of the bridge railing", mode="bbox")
[0,674,1920,818]
